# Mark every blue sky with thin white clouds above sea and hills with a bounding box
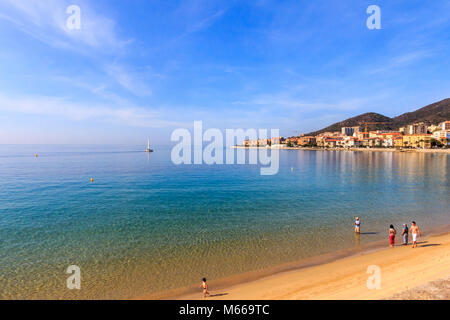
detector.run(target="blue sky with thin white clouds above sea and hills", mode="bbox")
[0,0,450,145]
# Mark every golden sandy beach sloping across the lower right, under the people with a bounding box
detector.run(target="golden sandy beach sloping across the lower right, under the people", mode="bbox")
[172,233,450,300]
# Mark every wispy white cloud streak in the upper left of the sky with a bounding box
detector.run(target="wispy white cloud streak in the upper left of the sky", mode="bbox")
[0,0,158,97]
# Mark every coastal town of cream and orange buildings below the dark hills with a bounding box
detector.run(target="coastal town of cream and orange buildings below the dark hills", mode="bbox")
[243,121,450,149]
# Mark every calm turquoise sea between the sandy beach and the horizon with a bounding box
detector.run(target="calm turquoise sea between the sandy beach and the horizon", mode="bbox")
[0,146,450,299]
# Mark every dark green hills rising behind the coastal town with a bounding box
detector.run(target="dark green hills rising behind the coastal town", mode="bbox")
[308,99,450,136]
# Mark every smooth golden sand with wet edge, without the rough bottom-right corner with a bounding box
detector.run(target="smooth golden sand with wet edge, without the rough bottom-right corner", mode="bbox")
[137,222,450,300]
